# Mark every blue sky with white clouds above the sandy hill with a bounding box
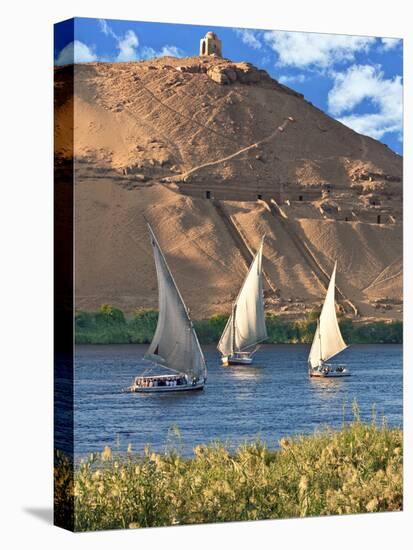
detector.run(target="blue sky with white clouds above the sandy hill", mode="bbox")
[54,18,403,154]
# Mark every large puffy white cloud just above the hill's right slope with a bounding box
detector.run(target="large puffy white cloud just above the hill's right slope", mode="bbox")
[328,65,403,139]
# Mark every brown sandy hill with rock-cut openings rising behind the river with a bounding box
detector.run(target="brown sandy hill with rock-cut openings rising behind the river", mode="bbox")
[55,57,402,319]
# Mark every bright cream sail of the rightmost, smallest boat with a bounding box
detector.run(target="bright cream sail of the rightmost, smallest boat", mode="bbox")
[308,262,347,368]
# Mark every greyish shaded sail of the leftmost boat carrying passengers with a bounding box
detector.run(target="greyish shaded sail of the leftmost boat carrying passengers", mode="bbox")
[145,224,206,378]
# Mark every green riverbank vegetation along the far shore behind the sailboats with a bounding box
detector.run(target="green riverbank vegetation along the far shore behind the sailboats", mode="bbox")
[75,304,403,344]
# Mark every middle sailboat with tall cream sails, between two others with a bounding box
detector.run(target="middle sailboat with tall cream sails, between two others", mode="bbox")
[218,237,267,366]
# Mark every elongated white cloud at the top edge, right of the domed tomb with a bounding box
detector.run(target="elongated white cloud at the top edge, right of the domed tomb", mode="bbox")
[264,31,376,69]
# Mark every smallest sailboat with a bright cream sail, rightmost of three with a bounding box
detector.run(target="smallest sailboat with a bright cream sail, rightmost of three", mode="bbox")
[308,262,350,378]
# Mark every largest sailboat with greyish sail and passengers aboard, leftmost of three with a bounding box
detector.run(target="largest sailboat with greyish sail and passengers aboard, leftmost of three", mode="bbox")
[128,224,207,393]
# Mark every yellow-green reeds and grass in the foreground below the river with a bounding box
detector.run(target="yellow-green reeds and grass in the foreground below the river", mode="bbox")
[55,420,403,531]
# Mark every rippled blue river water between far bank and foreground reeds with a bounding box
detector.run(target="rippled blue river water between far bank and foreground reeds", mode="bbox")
[75,345,403,456]
